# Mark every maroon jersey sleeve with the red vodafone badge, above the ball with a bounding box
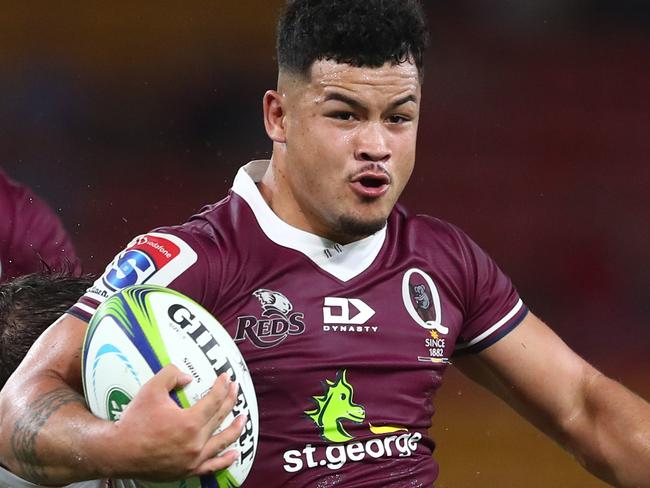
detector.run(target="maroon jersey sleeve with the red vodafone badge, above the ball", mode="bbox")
[67,228,204,322]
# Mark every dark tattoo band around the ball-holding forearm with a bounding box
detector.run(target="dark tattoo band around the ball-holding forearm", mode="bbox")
[11,388,86,483]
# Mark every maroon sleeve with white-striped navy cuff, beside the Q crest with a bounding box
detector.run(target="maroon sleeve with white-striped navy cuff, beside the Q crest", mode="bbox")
[448,225,528,354]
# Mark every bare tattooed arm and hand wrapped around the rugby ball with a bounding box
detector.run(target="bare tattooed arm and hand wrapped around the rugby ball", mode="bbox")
[0,315,243,484]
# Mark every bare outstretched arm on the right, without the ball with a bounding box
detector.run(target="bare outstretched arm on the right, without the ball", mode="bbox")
[456,314,650,487]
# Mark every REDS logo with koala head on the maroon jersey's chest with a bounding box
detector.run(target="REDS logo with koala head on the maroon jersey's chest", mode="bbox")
[235,288,305,349]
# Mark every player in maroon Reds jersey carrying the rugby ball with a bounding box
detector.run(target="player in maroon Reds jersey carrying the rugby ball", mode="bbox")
[0,0,650,488]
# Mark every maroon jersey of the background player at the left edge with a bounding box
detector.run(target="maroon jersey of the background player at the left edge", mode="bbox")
[0,170,80,281]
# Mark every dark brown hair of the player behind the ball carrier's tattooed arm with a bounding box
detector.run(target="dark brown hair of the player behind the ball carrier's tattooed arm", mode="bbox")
[0,273,98,488]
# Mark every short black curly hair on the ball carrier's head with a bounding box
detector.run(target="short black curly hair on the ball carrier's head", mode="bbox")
[277,0,429,77]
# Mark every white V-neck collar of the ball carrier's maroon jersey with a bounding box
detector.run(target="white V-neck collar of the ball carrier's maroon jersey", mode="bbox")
[232,161,386,281]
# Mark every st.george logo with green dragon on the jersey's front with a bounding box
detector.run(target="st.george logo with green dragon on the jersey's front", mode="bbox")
[282,370,422,473]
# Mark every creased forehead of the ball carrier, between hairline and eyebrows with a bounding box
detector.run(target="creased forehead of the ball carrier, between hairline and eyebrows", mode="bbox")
[309,60,420,95]
